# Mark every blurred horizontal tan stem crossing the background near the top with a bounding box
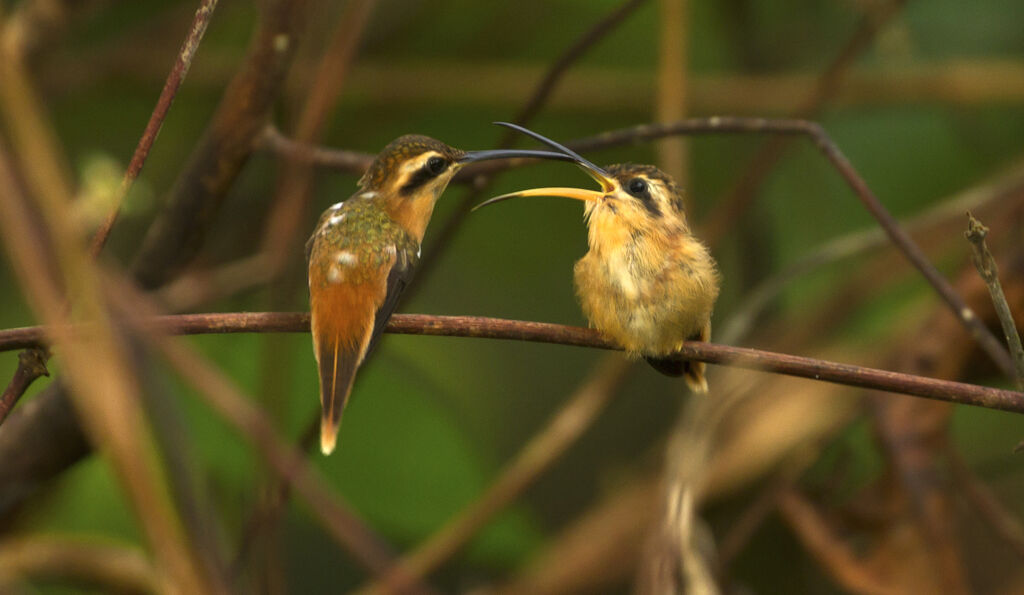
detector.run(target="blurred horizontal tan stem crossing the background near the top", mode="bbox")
[40,58,1024,117]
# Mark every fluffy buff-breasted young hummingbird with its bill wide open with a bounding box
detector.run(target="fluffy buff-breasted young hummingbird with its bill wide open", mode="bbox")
[476,123,719,392]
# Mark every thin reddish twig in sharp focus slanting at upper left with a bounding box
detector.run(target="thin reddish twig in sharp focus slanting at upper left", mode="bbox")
[89,0,217,256]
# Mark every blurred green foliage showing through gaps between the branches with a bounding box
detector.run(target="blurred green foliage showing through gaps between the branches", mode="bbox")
[0,0,1024,592]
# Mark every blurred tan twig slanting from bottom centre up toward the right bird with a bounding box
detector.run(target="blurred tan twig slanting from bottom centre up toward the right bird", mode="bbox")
[360,357,631,593]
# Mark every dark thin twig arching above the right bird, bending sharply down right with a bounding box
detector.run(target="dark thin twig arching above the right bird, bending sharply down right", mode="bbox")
[568,116,1015,378]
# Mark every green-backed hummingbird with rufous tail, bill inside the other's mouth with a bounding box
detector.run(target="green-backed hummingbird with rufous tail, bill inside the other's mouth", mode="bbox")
[306,135,565,455]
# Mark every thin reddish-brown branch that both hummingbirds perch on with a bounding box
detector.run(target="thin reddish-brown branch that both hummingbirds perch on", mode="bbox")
[0,312,1024,413]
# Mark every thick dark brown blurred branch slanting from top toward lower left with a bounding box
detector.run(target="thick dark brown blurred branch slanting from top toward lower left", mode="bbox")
[0,0,308,528]
